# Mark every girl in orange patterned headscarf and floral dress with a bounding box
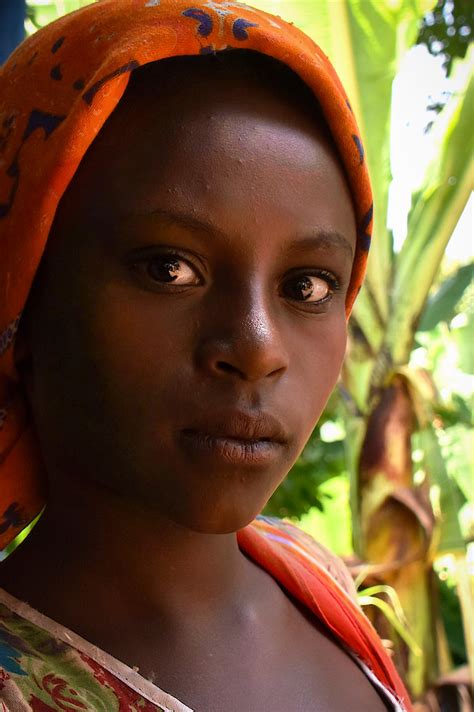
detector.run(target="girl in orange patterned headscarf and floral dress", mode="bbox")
[0,0,410,712]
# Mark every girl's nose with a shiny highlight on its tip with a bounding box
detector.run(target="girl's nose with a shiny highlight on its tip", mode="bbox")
[196,290,288,381]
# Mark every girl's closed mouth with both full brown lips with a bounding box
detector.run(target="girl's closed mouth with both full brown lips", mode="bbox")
[180,411,287,465]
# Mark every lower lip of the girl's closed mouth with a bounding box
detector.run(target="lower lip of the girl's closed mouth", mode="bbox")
[181,431,282,465]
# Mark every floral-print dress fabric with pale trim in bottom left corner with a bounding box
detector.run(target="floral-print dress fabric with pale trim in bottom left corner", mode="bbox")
[0,590,189,712]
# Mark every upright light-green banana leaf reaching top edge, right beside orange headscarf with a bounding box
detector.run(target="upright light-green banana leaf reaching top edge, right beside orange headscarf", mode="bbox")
[344,0,433,322]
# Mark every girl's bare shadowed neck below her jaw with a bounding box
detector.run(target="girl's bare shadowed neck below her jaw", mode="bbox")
[0,482,254,633]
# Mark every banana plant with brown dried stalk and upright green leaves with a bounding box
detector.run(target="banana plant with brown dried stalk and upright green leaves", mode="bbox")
[332,2,474,697]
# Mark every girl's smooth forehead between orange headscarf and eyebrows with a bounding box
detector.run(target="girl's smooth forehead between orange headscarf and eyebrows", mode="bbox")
[45,53,355,268]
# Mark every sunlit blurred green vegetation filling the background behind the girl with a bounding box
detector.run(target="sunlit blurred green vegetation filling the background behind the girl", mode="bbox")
[0,0,474,712]
